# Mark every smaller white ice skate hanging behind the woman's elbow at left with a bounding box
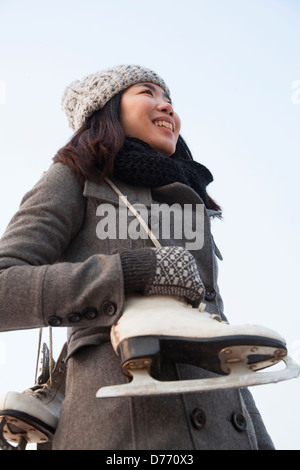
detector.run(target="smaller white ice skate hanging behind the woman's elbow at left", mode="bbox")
[0,344,66,450]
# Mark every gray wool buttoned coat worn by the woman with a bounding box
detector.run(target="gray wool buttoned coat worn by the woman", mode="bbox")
[0,164,274,450]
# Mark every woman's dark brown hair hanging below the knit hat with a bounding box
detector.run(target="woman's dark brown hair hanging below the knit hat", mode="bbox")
[53,91,220,210]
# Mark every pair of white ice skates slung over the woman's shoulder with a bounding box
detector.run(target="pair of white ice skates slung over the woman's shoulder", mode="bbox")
[0,296,299,449]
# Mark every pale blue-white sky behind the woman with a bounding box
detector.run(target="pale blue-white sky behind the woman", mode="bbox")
[0,0,300,450]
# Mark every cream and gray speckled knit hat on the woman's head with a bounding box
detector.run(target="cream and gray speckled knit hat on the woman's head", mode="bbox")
[62,65,170,131]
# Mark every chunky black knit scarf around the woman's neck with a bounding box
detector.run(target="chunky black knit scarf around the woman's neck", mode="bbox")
[113,137,213,204]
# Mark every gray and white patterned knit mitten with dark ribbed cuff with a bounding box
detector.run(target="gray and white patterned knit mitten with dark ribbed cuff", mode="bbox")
[120,247,204,306]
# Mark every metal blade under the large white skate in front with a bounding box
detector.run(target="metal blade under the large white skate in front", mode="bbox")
[96,356,300,398]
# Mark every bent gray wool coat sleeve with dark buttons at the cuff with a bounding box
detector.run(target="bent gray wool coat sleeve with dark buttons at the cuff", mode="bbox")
[0,163,124,331]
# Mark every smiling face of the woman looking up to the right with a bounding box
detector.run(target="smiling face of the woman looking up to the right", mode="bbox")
[121,82,181,157]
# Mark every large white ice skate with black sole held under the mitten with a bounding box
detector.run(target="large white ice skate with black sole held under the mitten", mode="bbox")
[96,296,299,398]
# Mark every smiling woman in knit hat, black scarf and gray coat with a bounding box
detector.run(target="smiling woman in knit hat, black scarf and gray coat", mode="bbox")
[0,66,284,450]
